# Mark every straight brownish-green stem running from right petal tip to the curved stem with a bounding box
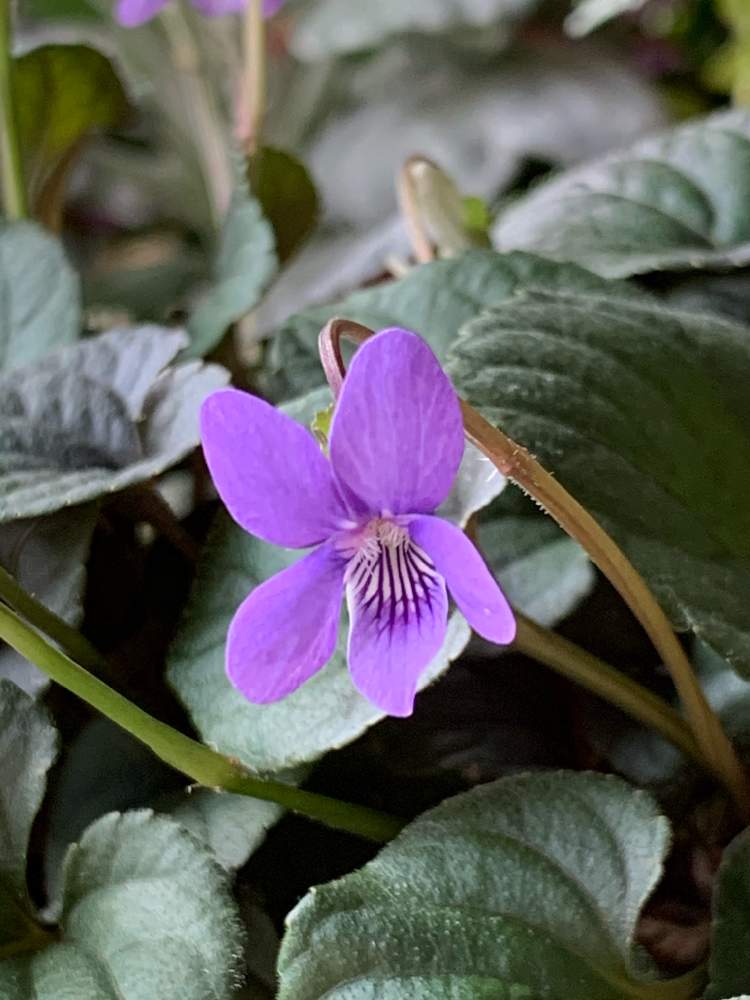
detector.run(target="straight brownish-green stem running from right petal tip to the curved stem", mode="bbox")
[514,611,706,767]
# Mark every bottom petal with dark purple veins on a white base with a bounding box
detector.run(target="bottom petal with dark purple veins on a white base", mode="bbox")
[346,541,448,716]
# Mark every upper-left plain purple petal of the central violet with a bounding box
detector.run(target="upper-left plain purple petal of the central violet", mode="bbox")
[201,389,346,548]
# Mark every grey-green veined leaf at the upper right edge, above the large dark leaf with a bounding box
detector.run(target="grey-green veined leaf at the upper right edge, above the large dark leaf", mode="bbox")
[493,110,750,277]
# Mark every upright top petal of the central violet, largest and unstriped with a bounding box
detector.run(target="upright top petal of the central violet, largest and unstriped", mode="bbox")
[330,328,464,514]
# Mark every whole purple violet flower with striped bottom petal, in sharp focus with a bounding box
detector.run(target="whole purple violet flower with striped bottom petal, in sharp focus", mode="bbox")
[201,329,515,715]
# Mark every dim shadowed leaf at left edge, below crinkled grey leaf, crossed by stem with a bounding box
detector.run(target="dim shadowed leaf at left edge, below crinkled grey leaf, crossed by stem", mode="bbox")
[0,504,97,694]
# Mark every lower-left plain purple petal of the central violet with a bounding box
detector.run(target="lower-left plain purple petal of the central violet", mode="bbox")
[226,544,344,705]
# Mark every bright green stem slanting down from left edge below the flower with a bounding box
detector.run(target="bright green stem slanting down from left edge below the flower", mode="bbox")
[0,603,404,842]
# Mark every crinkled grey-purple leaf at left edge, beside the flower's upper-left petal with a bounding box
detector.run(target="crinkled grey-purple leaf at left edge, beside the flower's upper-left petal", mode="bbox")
[0,326,227,523]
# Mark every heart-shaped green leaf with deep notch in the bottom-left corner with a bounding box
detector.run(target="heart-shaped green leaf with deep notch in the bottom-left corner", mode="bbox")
[0,681,242,1000]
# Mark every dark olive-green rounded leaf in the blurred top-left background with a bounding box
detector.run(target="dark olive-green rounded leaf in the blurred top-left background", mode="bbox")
[13,45,128,214]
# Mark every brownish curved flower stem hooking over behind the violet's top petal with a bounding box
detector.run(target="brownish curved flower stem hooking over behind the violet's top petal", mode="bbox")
[319,319,750,819]
